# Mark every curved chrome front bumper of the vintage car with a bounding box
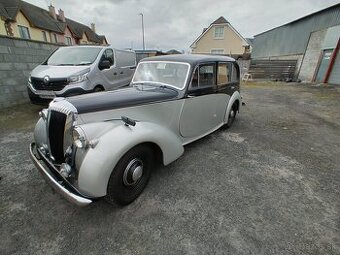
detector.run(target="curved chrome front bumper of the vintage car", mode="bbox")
[30,143,93,206]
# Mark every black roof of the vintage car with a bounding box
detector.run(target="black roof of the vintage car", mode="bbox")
[141,54,235,65]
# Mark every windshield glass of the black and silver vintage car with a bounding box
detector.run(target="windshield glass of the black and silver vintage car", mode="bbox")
[132,61,189,89]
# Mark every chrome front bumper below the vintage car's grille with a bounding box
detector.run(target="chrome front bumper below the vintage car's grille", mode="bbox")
[30,143,93,206]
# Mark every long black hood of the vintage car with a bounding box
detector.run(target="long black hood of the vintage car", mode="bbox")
[66,85,178,114]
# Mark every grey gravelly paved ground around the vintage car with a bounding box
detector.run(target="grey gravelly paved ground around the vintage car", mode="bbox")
[0,83,340,254]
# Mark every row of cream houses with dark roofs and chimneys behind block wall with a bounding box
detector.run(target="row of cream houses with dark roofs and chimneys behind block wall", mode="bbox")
[0,0,107,45]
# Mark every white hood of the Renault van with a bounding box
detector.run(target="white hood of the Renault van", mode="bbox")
[31,65,89,78]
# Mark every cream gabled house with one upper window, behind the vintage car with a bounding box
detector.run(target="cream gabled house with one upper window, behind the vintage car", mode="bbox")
[190,17,251,58]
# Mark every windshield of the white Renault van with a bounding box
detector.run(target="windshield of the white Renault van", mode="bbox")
[47,47,101,66]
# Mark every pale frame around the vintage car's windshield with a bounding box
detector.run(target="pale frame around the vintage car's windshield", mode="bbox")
[131,61,191,90]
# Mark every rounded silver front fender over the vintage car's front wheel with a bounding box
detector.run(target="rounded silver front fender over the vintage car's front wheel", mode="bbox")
[76,122,184,197]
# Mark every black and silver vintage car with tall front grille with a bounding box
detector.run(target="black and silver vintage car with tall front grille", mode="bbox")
[30,55,242,205]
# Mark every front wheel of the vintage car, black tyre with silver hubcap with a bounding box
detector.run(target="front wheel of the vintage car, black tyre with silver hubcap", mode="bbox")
[105,145,153,205]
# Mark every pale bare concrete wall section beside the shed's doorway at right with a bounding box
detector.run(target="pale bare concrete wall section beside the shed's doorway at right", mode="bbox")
[299,30,327,82]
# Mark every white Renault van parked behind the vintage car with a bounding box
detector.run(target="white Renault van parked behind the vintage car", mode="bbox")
[27,46,136,104]
